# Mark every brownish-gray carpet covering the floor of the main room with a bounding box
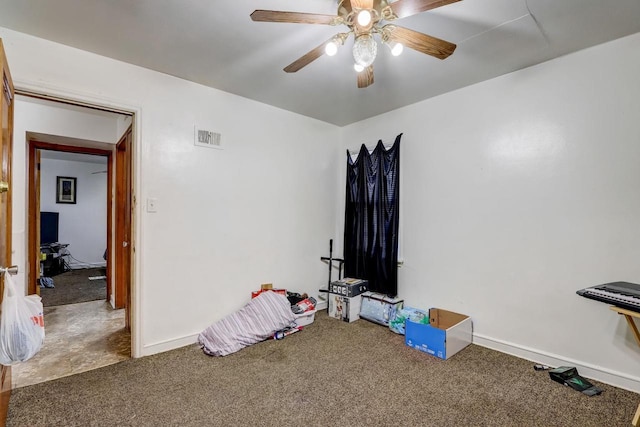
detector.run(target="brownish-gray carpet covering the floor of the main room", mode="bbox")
[7,312,640,427]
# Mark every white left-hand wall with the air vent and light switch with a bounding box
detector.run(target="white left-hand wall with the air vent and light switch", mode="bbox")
[0,28,339,356]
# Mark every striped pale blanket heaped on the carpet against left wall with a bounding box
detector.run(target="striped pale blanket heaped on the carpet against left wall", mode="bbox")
[198,291,296,356]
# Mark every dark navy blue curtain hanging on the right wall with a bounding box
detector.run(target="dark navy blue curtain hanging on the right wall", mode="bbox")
[343,134,402,296]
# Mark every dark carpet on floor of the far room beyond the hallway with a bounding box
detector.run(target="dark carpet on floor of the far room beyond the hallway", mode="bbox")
[40,268,107,307]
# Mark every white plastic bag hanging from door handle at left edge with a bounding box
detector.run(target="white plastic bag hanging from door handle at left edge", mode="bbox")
[0,274,44,365]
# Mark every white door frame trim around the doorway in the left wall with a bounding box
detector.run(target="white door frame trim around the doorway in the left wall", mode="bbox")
[14,81,144,358]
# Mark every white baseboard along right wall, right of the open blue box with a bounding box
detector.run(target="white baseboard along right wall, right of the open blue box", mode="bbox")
[473,334,640,393]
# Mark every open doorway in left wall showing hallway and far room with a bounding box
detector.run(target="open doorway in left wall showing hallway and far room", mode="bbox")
[14,95,133,387]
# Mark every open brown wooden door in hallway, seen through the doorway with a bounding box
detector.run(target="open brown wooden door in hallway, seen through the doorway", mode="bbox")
[114,127,133,328]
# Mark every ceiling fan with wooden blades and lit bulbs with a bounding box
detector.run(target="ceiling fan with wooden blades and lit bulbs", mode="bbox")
[251,0,460,88]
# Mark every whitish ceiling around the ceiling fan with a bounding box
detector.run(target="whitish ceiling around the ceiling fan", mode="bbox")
[0,0,640,126]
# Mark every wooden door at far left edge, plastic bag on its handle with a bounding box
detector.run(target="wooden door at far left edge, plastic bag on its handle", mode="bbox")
[0,39,14,426]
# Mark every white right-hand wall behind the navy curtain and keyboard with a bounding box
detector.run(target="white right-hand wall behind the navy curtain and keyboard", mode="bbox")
[336,34,640,391]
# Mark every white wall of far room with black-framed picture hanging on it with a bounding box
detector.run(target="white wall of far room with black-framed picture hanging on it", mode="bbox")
[40,159,107,268]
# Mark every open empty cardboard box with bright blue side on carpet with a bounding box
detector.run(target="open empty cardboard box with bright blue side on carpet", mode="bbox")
[405,308,472,359]
